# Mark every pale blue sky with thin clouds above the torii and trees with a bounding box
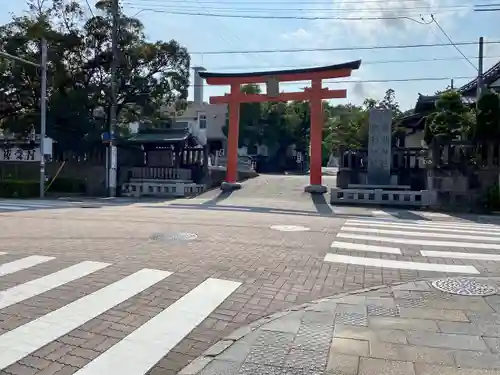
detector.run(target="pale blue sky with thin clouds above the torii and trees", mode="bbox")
[0,0,500,109]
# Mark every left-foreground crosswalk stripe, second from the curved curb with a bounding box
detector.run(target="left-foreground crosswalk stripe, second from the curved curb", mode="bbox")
[0,269,171,369]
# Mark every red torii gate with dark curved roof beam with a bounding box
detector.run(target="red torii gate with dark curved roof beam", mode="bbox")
[199,60,361,193]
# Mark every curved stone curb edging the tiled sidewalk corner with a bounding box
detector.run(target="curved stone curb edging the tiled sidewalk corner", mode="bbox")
[177,282,400,375]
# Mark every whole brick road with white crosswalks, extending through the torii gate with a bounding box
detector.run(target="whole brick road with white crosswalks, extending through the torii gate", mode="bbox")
[0,176,500,375]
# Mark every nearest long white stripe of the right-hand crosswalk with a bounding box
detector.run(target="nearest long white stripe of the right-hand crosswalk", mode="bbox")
[324,254,479,274]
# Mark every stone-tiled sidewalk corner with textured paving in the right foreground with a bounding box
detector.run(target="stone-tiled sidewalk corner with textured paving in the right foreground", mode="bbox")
[179,278,500,375]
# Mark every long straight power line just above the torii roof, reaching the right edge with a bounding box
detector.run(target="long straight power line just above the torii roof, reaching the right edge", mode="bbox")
[190,41,500,55]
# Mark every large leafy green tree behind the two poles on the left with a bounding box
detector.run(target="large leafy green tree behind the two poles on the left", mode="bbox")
[0,0,190,150]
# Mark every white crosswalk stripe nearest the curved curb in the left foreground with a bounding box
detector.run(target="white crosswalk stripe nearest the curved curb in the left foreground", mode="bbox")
[75,279,241,375]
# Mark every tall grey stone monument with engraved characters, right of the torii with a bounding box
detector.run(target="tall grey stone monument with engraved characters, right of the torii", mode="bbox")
[368,109,392,185]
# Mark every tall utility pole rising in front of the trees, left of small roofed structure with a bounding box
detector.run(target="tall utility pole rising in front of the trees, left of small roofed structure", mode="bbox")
[108,0,119,197]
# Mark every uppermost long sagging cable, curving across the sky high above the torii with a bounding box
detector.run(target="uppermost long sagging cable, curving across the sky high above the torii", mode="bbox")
[124,6,429,25]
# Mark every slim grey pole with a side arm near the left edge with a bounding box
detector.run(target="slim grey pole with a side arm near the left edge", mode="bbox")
[0,39,47,198]
